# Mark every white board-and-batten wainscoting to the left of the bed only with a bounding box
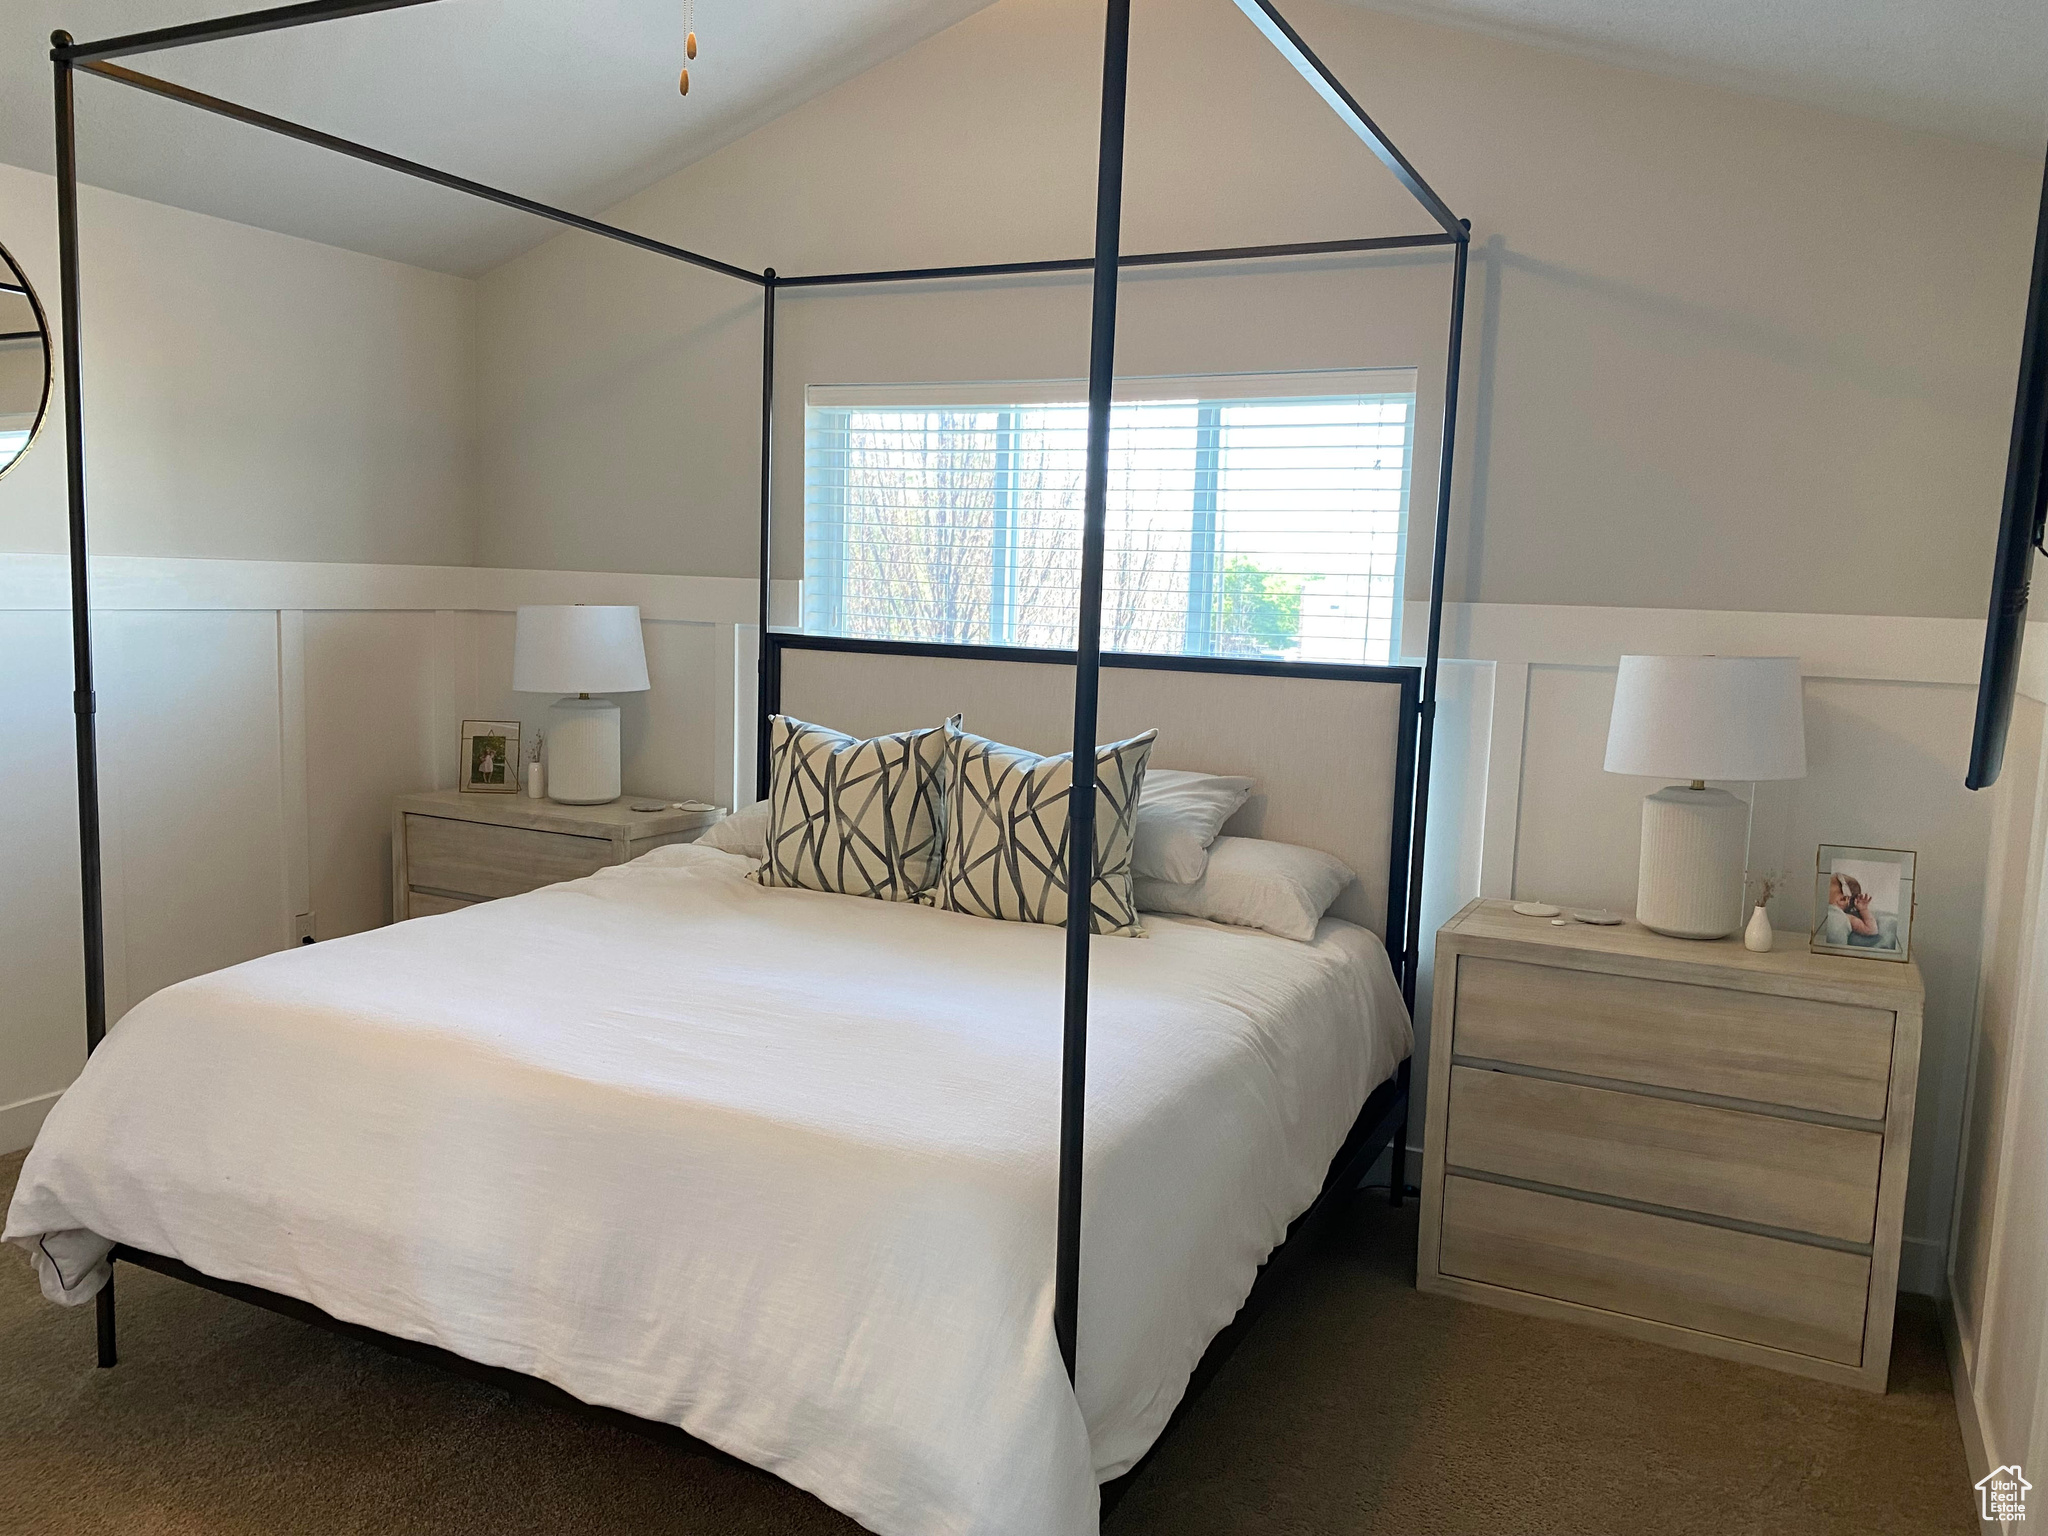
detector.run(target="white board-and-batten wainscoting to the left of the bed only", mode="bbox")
[0,555,797,1151]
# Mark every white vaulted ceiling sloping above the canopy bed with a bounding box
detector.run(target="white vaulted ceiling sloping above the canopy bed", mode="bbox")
[0,0,2048,272]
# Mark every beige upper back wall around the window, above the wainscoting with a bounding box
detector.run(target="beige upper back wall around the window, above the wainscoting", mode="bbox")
[481,0,2038,616]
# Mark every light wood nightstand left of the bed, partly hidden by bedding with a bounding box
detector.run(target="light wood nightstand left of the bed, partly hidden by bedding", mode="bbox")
[391,788,719,922]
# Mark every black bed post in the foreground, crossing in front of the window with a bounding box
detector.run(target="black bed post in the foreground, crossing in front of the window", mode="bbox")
[1053,0,1130,1380]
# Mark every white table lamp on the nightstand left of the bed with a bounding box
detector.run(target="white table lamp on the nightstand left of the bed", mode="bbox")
[512,604,647,805]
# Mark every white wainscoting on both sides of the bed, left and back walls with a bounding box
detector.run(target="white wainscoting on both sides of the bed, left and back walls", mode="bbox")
[0,555,2015,1290]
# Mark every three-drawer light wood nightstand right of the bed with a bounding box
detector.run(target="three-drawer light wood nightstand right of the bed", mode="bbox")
[1415,901,1921,1393]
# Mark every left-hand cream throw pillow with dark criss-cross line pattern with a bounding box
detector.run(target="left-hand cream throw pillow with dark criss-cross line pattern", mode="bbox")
[748,715,958,901]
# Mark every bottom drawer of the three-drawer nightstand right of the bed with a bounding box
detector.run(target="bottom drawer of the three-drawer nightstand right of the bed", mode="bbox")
[1440,1178,1870,1366]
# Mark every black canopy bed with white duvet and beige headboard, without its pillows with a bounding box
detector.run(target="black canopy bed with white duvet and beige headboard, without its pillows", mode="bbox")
[28,0,1470,1532]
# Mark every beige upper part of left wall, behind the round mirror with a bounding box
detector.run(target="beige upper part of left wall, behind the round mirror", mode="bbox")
[0,166,477,563]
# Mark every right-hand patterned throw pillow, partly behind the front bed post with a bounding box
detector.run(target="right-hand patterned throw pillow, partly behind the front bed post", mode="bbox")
[932,721,1157,936]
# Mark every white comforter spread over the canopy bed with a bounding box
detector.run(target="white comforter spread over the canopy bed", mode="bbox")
[6,846,1413,1536]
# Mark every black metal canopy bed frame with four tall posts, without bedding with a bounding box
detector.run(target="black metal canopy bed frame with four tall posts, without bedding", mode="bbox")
[39,0,1470,1513]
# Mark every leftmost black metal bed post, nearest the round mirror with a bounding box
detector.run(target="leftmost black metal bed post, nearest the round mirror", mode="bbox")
[49,33,115,1368]
